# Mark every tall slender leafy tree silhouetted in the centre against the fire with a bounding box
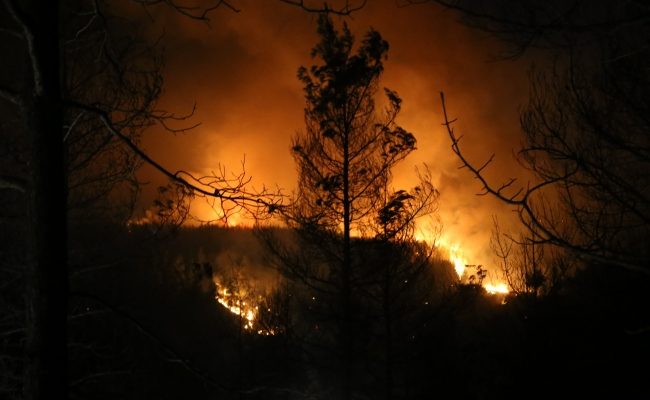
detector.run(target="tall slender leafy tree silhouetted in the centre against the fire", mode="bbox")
[270,15,437,398]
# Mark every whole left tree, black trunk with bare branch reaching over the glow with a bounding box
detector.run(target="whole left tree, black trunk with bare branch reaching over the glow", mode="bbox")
[0,0,277,399]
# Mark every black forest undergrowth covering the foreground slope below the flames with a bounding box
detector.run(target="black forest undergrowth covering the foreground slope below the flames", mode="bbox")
[60,228,650,399]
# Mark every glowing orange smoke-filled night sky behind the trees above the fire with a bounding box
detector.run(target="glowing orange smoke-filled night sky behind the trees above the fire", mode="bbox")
[134,0,527,265]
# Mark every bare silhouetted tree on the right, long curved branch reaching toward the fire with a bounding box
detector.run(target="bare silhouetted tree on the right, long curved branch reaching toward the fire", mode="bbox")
[430,1,650,273]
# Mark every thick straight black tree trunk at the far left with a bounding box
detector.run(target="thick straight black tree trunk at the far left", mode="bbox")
[15,0,68,400]
